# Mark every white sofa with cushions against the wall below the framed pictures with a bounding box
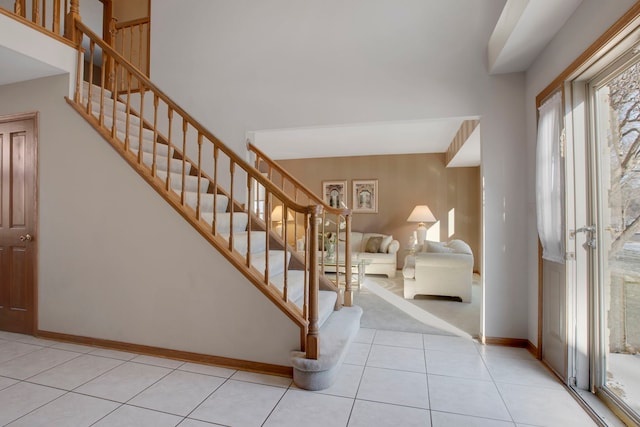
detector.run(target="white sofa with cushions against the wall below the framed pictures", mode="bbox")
[325,231,400,278]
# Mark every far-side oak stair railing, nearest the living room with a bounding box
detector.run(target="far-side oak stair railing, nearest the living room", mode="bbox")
[247,142,353,307]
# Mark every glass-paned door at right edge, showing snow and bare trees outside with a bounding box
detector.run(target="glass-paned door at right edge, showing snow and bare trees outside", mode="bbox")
[585,58,640,415]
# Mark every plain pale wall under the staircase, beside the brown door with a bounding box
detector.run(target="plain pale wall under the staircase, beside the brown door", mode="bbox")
[0,76,299,365]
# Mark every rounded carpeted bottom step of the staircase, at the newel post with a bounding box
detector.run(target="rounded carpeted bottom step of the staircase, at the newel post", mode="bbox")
[291,306,362,390]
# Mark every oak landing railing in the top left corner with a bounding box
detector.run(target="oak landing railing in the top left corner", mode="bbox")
[0,0,80,43]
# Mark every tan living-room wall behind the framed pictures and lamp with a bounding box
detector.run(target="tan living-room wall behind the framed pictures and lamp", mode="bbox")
[278,153,482,271]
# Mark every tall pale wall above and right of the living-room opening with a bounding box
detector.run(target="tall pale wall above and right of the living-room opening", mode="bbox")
[150,0,535,338]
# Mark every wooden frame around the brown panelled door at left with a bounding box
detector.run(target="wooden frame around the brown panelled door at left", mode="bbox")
[0,111,40,335]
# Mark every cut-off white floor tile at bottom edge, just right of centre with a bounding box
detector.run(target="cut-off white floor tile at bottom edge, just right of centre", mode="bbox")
[349,400,431,427]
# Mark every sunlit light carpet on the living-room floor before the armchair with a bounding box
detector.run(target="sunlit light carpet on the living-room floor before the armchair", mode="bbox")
[354,275,481,337]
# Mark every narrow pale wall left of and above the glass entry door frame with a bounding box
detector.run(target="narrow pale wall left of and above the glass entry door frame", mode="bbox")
[526,0,635,344]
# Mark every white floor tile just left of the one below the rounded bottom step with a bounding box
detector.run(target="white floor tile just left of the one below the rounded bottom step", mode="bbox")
[189,380,286,426]
